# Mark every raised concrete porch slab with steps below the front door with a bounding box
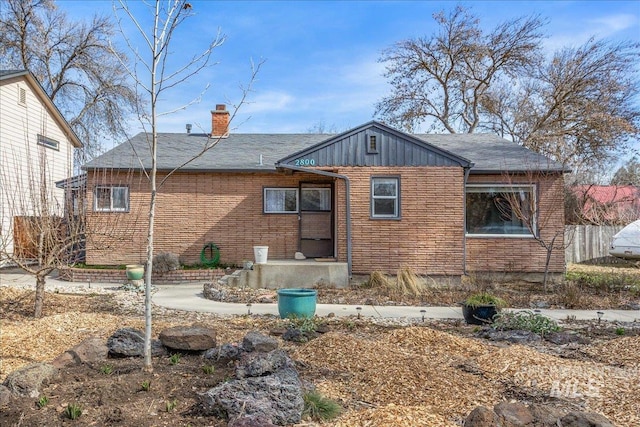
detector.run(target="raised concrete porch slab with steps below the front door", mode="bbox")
[228,259,349,289]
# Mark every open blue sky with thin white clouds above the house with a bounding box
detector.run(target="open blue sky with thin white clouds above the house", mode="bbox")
[58,0,640,156]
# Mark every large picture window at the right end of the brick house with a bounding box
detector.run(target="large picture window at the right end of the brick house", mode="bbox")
[466,185,535,236]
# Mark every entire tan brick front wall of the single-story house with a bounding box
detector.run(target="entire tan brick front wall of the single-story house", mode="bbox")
[87,167,564,276]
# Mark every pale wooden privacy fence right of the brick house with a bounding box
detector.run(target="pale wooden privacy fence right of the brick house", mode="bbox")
[564,225,624,263]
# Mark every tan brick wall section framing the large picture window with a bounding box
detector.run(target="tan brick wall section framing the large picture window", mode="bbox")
[467,175,565,273]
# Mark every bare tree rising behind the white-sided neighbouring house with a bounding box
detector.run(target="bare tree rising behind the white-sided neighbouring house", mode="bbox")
[0,0,136,160]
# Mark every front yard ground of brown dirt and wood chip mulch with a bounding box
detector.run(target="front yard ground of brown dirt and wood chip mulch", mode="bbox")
[0,266,640,427]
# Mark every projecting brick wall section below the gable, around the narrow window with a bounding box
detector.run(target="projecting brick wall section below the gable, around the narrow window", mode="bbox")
[337,167,464,275]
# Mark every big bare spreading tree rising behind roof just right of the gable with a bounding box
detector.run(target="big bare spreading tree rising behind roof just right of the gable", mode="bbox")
[376,6,543,133]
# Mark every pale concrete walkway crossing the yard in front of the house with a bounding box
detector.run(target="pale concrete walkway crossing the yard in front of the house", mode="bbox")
[0,270,640,322]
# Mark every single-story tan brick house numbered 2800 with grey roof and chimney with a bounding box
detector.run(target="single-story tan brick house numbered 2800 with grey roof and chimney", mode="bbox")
[85,105,565,277]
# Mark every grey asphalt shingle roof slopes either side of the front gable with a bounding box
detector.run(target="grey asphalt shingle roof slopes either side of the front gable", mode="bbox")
[85,133,563,173]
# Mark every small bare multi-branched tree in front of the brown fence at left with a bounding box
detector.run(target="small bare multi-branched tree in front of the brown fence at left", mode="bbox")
[0,141,133,318]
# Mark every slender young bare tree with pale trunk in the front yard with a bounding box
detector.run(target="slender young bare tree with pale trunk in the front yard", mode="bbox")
[119,0,261,371]
